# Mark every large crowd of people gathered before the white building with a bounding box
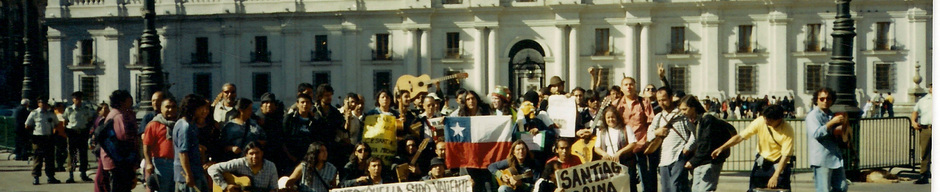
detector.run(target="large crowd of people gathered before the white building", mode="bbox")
[11,67,929,192]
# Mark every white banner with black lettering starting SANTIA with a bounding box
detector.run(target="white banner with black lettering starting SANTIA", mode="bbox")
[555,160,630,192]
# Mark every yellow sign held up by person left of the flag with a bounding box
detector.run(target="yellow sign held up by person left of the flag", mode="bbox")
[362,114,398,165]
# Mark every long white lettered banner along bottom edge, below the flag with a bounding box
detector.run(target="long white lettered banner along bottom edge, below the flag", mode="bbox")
[330,175,473,192]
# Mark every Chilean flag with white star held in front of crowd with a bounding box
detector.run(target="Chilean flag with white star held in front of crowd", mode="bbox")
[444,116,512,169]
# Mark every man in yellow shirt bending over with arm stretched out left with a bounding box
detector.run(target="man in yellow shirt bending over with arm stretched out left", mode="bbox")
[712,105,794,192]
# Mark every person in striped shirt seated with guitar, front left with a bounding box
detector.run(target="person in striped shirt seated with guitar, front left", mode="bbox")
[207,141,277,192]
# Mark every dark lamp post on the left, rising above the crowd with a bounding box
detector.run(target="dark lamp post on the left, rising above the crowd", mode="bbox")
[139,0,166,112]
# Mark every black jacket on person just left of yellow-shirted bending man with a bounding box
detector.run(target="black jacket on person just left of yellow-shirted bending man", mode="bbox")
[689,115,737,167]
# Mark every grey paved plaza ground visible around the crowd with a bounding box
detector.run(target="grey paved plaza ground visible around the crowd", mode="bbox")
[0,152,930,192]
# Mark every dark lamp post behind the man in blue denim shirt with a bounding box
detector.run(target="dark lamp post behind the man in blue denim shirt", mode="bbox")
[826,0,861,175]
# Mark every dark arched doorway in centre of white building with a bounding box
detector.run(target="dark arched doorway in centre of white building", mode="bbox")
[509,39,545,100]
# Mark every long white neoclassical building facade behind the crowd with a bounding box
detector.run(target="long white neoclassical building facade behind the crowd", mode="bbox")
[44,0,933,112]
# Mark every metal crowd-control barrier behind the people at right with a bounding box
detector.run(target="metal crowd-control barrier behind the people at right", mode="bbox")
[723,117,920,172]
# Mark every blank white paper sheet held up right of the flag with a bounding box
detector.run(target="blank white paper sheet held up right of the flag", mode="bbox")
[546,95,578,137]
